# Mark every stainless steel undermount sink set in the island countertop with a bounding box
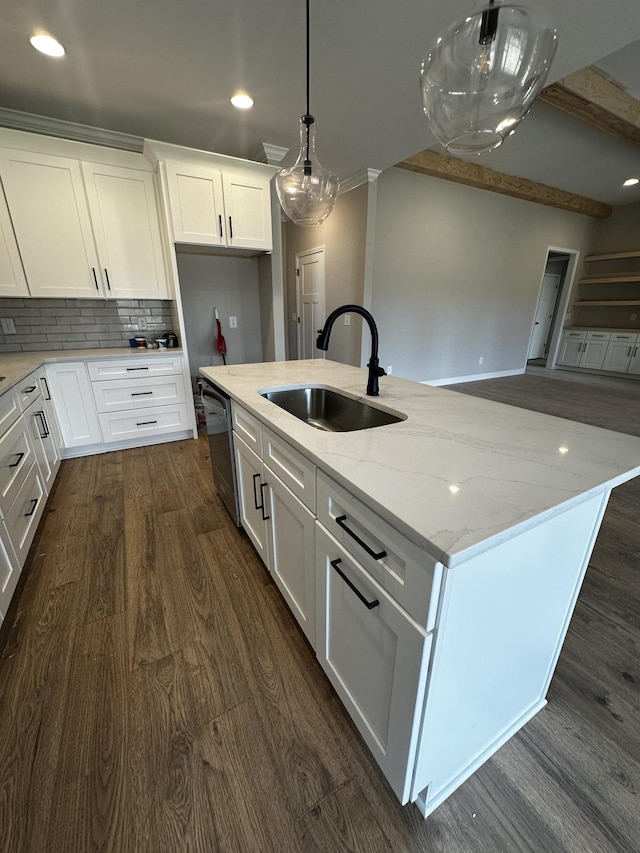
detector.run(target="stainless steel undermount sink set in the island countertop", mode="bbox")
[262,387,407,432]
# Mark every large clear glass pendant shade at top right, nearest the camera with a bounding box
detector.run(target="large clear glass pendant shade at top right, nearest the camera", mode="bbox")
[421,2,558,154]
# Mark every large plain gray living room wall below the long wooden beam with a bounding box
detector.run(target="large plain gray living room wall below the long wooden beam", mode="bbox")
[370,169,595,381]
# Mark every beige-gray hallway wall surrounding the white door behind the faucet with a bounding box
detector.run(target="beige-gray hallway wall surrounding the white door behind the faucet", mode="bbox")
[285,184,368,365]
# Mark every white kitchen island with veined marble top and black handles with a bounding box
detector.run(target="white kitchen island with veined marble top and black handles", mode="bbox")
[202,360,640,814]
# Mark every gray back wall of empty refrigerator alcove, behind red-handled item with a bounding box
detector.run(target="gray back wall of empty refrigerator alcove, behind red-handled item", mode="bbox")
[177,254,262,376]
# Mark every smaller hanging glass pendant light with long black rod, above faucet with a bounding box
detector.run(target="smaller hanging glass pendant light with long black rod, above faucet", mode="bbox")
[276,0,340,226]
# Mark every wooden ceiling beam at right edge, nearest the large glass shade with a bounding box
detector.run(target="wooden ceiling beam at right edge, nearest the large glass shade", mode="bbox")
[538,68,640,153]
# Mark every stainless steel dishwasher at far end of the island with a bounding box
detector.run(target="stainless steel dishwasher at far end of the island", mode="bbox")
[201,378,240,527]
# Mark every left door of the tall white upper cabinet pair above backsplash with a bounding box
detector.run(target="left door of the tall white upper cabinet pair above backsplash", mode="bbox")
[0,149,103,298]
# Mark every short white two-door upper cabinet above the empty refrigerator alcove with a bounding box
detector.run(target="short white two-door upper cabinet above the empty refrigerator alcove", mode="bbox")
[166,162,273,252]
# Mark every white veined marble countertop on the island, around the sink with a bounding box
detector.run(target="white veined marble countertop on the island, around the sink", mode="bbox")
[201,359,640,566]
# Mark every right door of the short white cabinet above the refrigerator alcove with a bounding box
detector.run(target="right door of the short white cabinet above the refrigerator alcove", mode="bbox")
[222,172,273,252]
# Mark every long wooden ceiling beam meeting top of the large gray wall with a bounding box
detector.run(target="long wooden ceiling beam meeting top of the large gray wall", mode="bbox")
[397,151,612,219]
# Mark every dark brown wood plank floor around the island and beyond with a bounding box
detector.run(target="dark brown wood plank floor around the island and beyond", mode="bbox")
[0,374,640,853]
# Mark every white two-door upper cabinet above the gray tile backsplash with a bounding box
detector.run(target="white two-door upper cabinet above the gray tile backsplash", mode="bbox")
[0,148,167,299]
